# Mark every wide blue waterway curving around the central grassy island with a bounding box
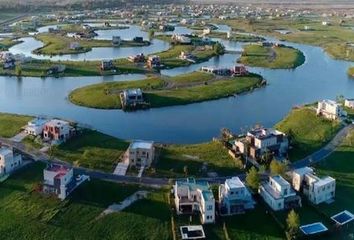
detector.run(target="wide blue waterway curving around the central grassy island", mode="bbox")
[0,26,354,143]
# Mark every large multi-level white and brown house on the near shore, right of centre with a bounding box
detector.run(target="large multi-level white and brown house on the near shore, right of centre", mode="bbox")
[233,128,289,159]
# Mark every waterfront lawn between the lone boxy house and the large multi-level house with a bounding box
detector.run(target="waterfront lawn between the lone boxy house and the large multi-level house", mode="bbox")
[151,141,242,177]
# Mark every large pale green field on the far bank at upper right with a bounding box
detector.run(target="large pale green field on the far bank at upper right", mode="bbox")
[213,17,354,61]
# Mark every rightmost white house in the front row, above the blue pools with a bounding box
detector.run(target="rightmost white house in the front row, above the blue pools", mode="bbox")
[292,167,336,204]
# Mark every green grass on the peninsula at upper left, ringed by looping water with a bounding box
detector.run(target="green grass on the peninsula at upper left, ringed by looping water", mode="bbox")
[34,33,149,55]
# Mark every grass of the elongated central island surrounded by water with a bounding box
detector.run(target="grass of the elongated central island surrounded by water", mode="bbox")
[69,73,262,109]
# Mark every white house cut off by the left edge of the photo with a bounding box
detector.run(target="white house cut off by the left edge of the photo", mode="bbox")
[0,147,22,176]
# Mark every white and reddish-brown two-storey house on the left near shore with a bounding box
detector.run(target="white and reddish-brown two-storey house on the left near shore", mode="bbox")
[43,119,75,143]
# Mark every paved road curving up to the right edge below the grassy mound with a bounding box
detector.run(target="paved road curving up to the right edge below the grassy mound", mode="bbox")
[290,124,354,169]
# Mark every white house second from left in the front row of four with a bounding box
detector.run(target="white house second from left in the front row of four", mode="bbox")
[219,177,256,215]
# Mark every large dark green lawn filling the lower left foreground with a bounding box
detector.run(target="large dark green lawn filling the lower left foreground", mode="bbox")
[0,163,172,240]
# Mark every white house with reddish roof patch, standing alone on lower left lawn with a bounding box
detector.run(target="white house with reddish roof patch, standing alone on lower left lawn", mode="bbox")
[43,164,76,200]
